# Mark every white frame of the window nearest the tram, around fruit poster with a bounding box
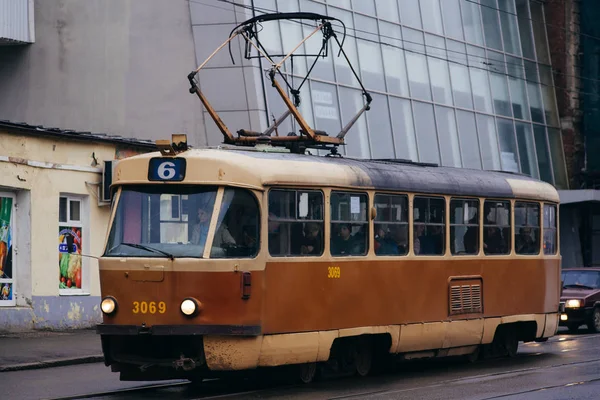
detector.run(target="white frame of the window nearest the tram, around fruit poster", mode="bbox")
[57,193,90,296]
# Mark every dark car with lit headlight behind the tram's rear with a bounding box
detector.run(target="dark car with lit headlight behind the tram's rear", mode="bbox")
[559,268,600,332]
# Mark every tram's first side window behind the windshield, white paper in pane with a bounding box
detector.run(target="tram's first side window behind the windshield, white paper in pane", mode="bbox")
[268,189,325,257]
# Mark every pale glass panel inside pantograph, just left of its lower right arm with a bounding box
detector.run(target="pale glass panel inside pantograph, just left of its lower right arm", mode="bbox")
[310,81,340,136]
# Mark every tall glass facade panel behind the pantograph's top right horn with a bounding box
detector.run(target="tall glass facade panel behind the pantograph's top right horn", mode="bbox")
[328,6,360,87]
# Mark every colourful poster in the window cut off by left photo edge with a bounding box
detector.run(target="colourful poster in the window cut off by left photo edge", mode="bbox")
[0,196,15,305]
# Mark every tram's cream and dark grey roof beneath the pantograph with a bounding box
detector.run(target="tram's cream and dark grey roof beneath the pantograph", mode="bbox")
[115,149,559,202]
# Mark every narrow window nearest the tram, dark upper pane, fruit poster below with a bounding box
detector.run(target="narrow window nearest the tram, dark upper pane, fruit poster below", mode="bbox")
[58,196,85,294]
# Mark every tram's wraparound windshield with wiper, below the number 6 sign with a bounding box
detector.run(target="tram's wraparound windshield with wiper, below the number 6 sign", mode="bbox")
[105,185,260,258]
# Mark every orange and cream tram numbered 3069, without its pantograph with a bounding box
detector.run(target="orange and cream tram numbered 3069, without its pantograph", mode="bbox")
[97,136,560,382]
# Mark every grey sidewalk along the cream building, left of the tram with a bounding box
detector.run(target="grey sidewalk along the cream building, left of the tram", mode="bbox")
[0,329,104,373]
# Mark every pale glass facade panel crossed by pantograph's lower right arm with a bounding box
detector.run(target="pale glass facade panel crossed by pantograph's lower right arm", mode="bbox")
[342,86,373,158]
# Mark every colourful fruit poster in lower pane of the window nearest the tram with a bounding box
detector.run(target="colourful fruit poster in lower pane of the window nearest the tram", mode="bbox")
[58,226,82,289]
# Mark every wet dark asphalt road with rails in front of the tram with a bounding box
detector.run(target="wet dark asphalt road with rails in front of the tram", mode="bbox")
[0,330,600,400]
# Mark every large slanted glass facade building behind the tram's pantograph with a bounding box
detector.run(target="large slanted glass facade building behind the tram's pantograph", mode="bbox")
[252,0,568,189]
